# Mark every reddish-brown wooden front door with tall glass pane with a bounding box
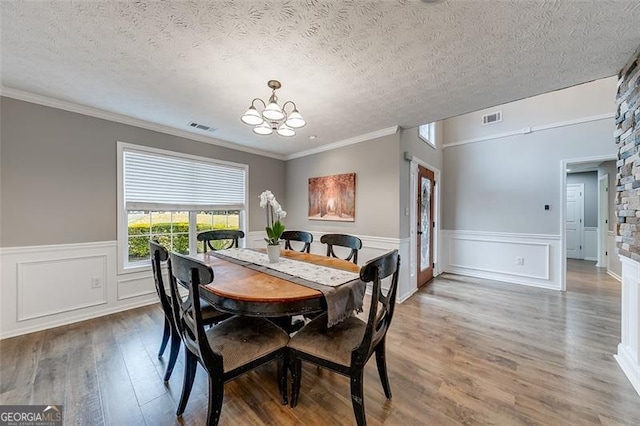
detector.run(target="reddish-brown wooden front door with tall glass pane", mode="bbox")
[416,166,436,287]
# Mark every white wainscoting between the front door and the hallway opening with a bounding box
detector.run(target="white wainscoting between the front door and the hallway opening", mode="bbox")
[440,230,562,290]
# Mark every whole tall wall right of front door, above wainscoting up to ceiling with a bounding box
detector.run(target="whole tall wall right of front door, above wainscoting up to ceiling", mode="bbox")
[442,77,617,235]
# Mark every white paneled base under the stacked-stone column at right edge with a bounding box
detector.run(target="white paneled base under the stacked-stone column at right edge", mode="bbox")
[615,256,640,394]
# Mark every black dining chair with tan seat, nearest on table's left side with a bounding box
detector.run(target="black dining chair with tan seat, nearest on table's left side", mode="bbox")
[168,253,289,425]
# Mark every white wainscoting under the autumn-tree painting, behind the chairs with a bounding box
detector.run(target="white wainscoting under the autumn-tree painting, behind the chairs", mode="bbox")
[245,231,416,303]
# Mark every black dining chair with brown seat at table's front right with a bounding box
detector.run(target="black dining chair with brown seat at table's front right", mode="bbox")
[288,250,400,426]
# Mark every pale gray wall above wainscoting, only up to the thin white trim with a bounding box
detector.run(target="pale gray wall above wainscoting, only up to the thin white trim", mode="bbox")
[442,119,615,235]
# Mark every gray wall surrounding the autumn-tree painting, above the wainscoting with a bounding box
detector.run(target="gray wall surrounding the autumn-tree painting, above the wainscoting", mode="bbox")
[283,134,400,238]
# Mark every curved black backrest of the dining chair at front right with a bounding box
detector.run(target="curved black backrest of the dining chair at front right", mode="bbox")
[352,250,400,365]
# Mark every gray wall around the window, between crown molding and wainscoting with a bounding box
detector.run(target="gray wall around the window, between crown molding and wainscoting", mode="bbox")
[0,97,286,247]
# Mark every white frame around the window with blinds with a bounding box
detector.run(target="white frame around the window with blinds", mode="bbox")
[116,141,249,275]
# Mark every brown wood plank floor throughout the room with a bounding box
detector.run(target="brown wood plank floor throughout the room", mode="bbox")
[0,261,640,426]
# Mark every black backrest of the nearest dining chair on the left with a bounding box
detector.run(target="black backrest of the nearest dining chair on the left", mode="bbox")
[169,253,222,360]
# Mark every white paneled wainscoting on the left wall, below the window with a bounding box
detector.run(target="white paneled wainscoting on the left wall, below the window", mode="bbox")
[0,241,157,338]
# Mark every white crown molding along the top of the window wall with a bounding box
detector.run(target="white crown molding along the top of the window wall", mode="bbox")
[0,86,286,160]
